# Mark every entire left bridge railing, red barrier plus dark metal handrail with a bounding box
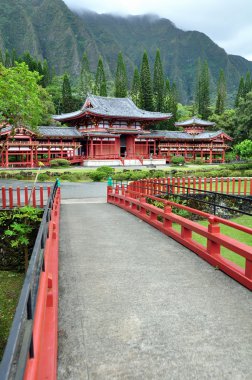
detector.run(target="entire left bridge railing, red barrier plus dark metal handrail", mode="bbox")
[0,181,60,380]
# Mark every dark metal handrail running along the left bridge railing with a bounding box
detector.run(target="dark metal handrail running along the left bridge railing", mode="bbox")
[0,181,58,380]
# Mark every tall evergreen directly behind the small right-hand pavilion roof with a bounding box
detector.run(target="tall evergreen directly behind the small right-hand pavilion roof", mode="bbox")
[196,61,210,119]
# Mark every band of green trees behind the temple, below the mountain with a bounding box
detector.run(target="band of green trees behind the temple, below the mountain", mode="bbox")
[0,50,252,141]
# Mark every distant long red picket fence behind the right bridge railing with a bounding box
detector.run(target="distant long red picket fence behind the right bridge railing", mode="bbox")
[128,177,252,196]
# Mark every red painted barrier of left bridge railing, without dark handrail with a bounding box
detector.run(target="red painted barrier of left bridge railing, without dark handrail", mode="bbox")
[24,188,60,380]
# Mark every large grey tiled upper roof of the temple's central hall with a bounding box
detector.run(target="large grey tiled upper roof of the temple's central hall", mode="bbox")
[52,95,172,121]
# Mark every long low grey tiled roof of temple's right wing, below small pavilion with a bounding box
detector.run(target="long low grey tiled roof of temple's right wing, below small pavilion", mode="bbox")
[139,131,226,140]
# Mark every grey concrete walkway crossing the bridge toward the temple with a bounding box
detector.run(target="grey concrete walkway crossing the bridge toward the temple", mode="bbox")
[58,185,252,380]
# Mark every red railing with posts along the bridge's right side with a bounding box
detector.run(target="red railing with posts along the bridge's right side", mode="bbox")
[107,185,252,290]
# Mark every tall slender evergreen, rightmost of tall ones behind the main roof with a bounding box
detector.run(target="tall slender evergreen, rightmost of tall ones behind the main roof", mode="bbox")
[153,49,164,112]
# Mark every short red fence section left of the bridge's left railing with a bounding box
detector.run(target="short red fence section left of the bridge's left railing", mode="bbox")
[0,186,51,209]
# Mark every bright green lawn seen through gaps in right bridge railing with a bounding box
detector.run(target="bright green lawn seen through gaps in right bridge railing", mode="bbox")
[173,215,252,268]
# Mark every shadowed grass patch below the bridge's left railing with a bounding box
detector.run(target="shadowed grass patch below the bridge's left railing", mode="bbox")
[0,271,24,360]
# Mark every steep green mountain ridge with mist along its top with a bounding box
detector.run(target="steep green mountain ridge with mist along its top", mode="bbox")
[0,0,252,102]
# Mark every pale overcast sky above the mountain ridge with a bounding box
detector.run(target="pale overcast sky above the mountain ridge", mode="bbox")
[64,0,252,61]
